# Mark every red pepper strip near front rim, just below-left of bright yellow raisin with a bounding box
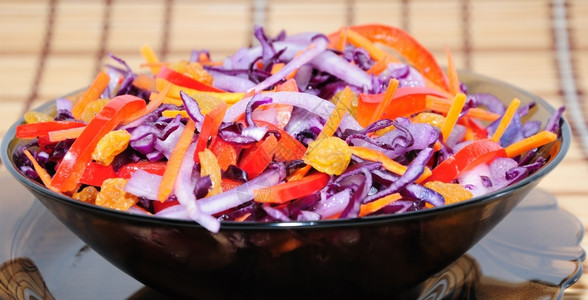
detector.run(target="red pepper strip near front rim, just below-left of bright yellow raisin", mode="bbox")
[253,172,331,204]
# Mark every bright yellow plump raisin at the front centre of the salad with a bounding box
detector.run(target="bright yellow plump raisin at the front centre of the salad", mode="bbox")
[302,136,351,175]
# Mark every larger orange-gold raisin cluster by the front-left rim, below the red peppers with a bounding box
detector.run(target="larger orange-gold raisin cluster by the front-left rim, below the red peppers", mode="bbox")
[96,178,139,210]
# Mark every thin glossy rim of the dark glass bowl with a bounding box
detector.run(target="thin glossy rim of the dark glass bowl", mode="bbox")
[0,70,572,231]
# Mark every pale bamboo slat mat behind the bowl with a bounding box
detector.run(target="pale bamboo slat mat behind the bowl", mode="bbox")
[0,0,588,299]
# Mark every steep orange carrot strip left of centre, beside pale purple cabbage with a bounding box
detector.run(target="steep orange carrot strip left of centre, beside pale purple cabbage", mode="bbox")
[157,119,196,202]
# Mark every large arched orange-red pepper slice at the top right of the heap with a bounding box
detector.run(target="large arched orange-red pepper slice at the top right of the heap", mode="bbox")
[330,24,449,91]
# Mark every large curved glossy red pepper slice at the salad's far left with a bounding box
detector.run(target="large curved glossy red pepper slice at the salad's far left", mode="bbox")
[51,95,145,192]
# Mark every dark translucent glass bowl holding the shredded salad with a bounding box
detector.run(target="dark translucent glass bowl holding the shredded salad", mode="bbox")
[1,72,572,299]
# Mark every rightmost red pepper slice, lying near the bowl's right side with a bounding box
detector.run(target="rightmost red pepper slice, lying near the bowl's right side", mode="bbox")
[426,139,506,182]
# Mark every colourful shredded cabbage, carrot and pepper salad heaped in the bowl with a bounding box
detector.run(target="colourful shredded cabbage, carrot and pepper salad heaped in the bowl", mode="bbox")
[13,24,564,232]
